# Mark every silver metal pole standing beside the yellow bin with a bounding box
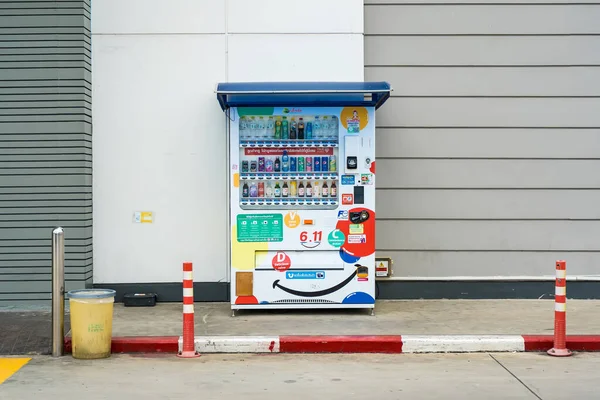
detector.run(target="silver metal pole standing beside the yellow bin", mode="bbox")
[52,228,65,357]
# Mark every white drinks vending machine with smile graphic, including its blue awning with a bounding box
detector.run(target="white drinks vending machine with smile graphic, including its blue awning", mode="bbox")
[216,82,391,312]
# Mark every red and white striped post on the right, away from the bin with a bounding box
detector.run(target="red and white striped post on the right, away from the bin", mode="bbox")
[548,260,572,357]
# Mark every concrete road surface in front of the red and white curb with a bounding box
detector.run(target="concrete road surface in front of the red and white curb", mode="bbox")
[0,353,600,400]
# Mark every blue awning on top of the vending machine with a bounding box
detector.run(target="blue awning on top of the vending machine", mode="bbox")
[215,82,392,110]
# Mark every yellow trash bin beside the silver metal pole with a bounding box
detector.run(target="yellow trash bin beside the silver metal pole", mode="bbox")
[68,289,115,360]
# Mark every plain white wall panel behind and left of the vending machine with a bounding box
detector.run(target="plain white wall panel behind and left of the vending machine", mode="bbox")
[92,0,364,283]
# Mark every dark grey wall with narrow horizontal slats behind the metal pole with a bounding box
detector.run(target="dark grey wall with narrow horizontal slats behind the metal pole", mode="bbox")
[0,0,92,306]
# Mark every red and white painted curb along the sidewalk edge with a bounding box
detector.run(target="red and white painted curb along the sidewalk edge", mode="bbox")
[65,335,600,354]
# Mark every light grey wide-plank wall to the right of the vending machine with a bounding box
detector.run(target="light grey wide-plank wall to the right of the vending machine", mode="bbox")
[365,0,600,277]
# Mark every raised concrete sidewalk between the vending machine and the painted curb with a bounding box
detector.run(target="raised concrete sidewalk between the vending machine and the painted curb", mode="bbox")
[113,300,600,336]
